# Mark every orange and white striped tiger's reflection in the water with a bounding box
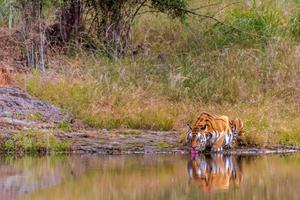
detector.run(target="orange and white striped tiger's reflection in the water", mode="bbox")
[187,154,243,192]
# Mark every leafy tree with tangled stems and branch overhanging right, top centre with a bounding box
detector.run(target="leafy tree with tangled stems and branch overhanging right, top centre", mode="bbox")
[89,0,187,59]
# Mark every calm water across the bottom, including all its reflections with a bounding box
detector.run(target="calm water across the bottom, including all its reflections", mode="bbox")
[0,154,300,200]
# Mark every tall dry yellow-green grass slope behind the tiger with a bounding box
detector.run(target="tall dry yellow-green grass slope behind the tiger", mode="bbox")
[17,1,300,145]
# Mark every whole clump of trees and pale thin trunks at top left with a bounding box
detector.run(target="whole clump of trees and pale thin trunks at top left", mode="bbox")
[12,0,188,63]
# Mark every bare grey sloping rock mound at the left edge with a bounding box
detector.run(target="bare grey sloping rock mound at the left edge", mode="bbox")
[0,87,70,128]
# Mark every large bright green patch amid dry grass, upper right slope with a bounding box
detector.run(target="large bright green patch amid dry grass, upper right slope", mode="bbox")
[212,8,281,47]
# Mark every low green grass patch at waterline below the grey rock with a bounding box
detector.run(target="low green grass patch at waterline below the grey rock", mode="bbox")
[0,129,70,155]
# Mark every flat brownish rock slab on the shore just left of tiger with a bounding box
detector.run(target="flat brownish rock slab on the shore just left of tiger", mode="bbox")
[57,129,185,154]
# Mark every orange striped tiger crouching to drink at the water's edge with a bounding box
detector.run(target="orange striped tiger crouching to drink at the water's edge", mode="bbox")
[187,112,234,152]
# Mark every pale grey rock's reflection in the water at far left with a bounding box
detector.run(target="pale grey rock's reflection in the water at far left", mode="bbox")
[0,157,67,199]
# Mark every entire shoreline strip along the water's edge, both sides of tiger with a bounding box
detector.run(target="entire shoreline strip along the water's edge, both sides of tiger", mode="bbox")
[0,129,300,156]
